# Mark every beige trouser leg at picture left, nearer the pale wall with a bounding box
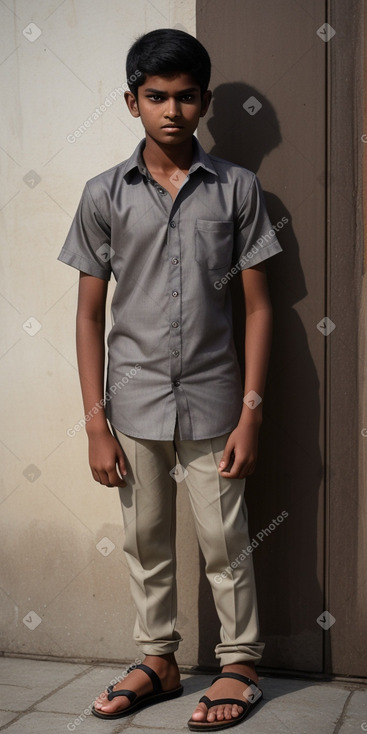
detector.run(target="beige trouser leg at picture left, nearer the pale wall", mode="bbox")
[114,429,181,655]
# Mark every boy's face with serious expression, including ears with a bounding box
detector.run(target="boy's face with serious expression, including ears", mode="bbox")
[125,73,211,145]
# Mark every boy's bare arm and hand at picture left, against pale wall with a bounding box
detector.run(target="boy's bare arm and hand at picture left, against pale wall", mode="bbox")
[76,273,126,487]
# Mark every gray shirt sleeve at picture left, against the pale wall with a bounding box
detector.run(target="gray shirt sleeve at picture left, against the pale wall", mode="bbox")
[57,183,113,280]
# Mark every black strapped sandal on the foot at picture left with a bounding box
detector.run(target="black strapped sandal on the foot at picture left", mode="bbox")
[91,663,183,719]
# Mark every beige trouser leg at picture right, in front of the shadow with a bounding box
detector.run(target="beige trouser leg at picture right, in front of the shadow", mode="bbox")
[176,434,264,665]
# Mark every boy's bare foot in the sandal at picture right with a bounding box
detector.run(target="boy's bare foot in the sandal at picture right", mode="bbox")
[191,663,259,724]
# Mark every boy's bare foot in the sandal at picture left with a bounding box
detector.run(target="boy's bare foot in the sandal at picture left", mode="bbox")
[94,653,180,714]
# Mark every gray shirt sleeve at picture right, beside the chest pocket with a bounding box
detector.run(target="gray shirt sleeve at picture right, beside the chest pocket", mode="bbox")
[232,174,282,270]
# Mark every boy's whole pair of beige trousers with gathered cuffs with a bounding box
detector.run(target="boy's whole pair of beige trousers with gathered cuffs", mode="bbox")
[113,424,264,665]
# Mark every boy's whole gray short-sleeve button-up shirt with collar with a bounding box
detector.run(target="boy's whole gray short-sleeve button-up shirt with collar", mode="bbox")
[58,137,282,440]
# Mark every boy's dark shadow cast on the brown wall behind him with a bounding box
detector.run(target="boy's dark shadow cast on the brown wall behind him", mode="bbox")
[198,83,324,672]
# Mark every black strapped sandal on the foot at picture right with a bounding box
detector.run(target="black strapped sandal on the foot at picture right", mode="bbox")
[187,673,263,731]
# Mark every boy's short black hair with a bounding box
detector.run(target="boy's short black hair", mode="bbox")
[126,28,211,99]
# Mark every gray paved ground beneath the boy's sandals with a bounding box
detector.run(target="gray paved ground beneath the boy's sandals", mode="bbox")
[0,657,367,734]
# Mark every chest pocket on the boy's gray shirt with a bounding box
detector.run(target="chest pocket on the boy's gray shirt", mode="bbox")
[195,219,233,270]
